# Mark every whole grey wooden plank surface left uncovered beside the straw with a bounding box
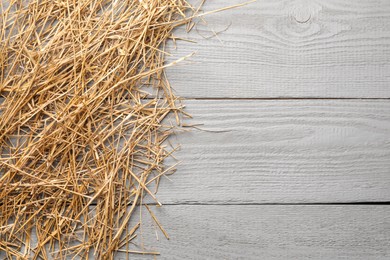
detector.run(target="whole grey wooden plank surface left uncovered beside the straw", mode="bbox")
[123,0,390,260]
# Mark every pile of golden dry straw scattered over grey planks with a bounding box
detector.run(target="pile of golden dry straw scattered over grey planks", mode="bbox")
[0,0,196,259]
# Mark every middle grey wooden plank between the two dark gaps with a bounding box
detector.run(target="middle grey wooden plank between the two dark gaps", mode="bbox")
[153,100,390,204]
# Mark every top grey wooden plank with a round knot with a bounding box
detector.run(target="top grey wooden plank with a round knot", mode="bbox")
[168,0,390,98]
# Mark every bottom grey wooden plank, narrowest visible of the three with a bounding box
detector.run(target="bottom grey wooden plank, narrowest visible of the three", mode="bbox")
[115,205,390,260]
